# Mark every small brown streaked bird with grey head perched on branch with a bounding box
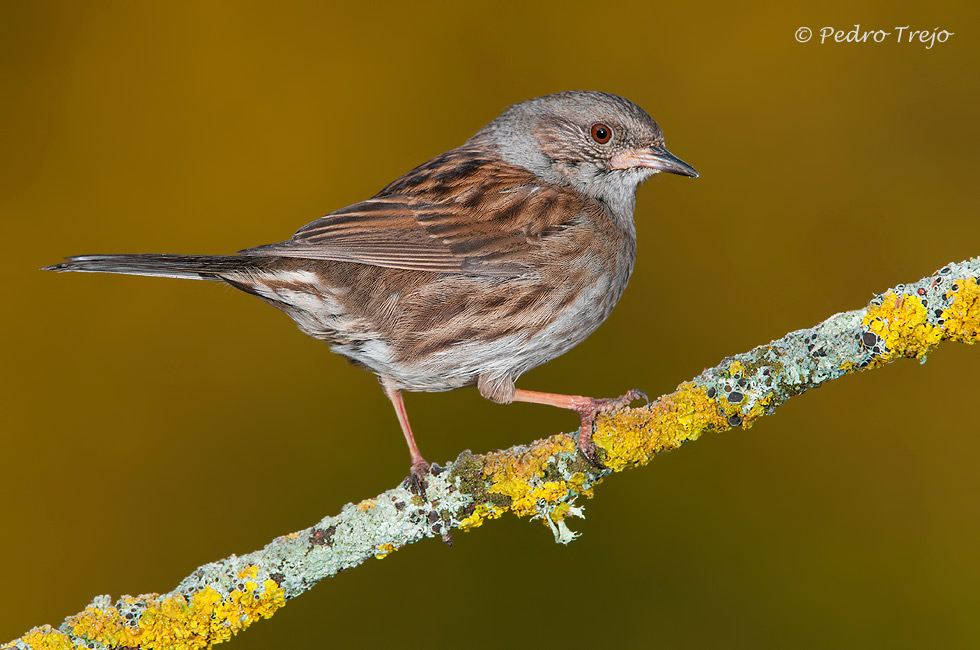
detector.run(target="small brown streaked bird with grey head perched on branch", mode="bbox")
[45,92,698,486]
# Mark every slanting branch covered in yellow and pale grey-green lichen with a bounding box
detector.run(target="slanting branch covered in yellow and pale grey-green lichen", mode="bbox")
[3,258,980,649]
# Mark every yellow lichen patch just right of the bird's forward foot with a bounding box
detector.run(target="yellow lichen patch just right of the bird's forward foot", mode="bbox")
[593,383,729,472]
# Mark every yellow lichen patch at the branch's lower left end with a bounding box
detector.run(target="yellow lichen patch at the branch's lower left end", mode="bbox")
[67,567,286,650]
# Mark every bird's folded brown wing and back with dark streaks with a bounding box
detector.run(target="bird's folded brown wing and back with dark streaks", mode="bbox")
[240,151,586,277]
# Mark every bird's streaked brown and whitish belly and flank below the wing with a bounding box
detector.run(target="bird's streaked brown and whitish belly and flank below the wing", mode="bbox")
[244,264,628,392]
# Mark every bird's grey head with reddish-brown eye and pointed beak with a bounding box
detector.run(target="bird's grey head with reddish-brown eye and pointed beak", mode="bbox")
[470,91,698,220]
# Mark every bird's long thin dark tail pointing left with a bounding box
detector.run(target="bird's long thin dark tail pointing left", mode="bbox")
[41,253,256,280]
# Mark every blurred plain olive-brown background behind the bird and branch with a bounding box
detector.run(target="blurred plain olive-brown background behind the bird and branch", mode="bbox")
[0,0,980,649]
